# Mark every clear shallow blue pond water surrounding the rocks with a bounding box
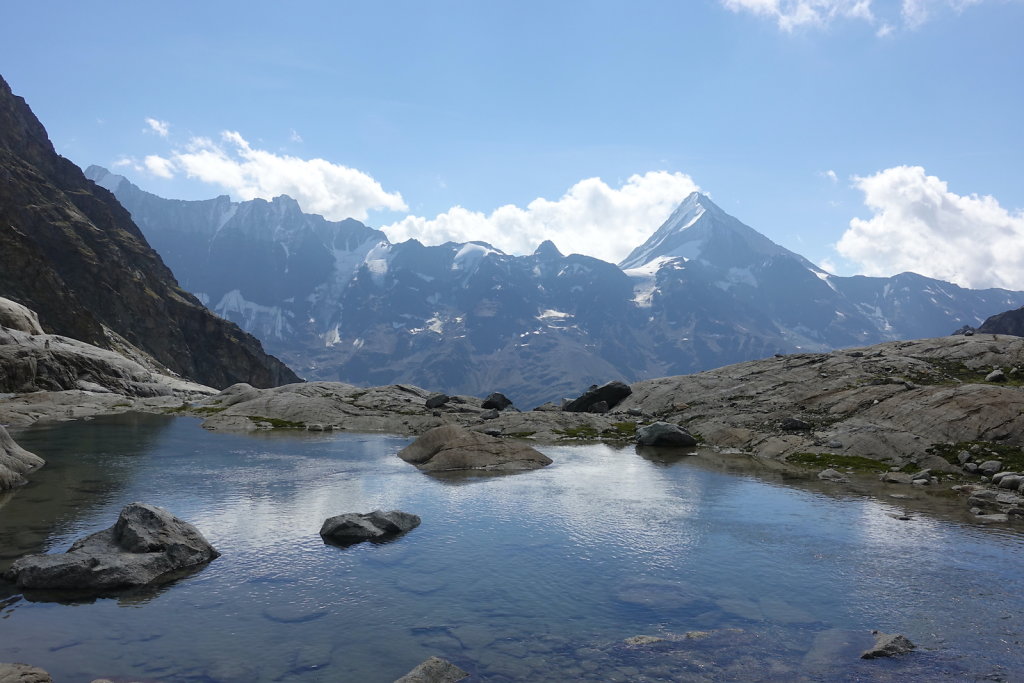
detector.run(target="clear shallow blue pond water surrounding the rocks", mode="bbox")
[0,416,1024,683]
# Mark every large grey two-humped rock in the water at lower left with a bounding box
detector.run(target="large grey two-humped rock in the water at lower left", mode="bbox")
[4,503,220,591]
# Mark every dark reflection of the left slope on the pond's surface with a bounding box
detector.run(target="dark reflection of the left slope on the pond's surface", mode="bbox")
[0,413,174,571]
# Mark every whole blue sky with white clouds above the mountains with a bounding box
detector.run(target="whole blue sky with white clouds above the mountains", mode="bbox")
[0,0,1024,290]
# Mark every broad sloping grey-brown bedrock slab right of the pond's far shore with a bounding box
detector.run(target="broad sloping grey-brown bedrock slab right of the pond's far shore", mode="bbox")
[612,335,1024,470]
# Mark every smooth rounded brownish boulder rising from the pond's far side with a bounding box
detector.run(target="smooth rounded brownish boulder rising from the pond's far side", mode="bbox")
[398,425,551,472]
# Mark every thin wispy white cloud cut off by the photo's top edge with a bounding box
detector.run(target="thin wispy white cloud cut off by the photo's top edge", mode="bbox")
[719,0,1003,31]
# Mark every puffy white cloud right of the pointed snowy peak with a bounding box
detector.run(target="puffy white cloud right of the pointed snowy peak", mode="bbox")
[836,166,1024,290]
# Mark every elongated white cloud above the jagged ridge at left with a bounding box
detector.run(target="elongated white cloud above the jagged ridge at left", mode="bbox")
[145,131,408,220]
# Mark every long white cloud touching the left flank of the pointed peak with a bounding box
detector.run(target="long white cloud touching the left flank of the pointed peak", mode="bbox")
[381,171,698,262]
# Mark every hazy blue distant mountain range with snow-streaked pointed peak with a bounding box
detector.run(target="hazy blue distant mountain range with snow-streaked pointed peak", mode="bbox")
[87,167,1024,407]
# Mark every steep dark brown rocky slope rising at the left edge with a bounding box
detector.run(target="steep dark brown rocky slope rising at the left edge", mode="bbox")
[0,78,300,387]
